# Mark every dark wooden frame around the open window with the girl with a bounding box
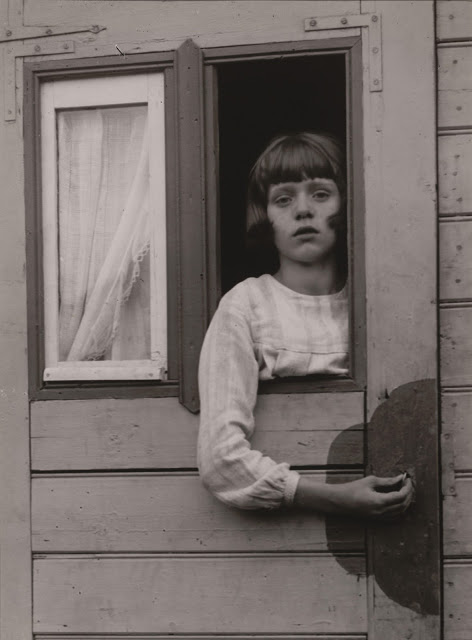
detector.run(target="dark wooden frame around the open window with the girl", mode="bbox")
[202,36,367,394]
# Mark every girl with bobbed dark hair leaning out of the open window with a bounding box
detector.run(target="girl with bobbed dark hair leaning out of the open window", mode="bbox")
[198,133,412,517]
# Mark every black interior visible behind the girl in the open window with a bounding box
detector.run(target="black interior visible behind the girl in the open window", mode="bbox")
[218,53,346,293]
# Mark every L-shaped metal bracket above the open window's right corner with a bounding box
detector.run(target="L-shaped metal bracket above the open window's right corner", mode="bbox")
[305,13,382,91]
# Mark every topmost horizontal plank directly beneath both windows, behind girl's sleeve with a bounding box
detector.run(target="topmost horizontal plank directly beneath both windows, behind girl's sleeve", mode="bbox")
[31,392,363,471]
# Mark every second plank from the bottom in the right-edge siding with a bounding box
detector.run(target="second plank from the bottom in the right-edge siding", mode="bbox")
[443,475,472,556]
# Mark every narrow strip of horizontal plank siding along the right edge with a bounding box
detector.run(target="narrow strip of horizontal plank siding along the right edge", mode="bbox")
[437,1,472,640]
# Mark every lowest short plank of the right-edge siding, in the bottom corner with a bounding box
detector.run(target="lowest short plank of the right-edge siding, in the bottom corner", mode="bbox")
[444,560,472,640]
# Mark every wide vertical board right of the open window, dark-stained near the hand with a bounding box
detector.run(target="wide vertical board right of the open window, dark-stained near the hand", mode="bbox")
[364,1,440,640]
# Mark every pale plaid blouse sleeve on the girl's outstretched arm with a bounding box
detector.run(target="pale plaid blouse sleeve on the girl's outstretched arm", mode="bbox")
[198,290,299,509]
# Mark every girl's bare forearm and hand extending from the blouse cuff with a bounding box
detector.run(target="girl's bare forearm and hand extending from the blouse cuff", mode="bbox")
[294,474,414,519]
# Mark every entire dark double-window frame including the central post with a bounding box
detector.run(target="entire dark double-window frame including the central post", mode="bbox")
[24,36,367,404]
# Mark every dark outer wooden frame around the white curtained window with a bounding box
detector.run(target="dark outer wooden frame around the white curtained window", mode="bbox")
[24,51,180,400]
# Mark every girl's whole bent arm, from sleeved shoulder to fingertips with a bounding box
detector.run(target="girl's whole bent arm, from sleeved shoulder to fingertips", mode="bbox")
[198,286,413,517]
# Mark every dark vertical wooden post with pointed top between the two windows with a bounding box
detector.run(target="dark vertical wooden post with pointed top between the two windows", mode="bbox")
[176,40,207,413]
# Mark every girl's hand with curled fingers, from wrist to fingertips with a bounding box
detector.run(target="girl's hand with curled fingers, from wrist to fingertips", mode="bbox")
[331,474,413,518]
